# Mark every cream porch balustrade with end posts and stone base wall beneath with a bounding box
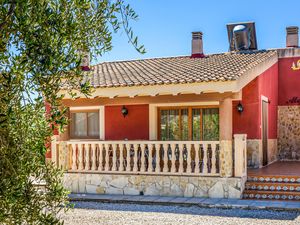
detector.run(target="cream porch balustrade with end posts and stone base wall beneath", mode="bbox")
[51,135,247,198]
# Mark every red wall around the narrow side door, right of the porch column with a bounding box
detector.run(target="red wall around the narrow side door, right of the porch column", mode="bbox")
[232,63,278,139]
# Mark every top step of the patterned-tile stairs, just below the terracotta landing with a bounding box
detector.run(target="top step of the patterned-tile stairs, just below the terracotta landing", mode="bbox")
[247,175,300,184]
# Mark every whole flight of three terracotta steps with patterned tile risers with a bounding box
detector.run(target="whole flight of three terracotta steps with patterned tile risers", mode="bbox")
[243,174,300,201]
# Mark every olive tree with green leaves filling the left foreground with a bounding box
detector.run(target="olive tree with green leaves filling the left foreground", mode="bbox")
[0,0,145,224]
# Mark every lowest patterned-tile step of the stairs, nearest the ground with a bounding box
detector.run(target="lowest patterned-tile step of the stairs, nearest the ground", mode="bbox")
[243,190,300,201]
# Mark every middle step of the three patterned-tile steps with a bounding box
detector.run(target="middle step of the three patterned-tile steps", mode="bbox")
[245,181,300,193]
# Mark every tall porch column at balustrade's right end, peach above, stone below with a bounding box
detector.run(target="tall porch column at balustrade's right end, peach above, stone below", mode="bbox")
[219,98,233,177]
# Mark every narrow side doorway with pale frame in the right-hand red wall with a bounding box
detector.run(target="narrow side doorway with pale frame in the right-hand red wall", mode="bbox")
[261,95,269,166]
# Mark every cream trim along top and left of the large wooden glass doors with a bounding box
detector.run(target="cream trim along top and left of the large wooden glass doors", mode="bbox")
[149,101,220,141]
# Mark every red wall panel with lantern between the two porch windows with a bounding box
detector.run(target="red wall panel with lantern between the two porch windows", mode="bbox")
[105,105,149,140]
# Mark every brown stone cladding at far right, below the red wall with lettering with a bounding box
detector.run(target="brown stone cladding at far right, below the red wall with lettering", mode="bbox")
[278,106,300,160]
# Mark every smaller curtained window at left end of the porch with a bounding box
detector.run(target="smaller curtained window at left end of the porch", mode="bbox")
[70,111,99,139]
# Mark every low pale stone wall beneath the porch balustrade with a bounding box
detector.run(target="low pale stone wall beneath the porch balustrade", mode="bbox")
[65,173,245,198]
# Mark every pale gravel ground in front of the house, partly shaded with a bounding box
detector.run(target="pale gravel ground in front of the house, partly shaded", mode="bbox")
[61,202,300,225]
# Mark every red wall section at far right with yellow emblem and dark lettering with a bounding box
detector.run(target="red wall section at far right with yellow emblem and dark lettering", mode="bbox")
[278,57,300,105]
